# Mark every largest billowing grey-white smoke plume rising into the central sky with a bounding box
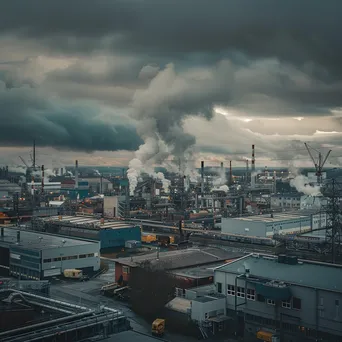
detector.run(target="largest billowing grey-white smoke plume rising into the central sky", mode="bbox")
[127,62,233,194]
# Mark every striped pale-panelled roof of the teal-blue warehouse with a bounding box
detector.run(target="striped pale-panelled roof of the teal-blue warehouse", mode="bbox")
[41,215,137,230]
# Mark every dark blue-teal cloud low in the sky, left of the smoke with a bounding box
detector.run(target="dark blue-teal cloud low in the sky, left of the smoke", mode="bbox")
[0,81,141,152]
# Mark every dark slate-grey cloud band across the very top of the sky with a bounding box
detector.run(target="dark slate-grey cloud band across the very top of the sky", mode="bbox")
[0,0,342,75]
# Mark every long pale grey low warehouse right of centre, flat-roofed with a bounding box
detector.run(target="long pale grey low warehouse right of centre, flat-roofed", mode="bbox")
[221,213,311,238]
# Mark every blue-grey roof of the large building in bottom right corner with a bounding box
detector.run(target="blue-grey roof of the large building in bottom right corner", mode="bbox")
[216,254,342,292]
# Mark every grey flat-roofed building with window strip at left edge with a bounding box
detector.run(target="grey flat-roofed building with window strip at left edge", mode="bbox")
[0,227,100,280]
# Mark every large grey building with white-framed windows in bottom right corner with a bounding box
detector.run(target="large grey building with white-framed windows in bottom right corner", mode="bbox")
[215,254,342,342]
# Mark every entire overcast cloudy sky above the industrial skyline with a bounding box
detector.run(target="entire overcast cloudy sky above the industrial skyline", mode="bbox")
[0,0,342,170]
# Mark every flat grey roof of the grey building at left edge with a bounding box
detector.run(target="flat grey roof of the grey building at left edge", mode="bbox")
[0,227,97,250]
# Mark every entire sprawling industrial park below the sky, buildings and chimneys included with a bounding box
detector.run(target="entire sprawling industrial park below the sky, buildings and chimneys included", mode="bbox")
[0,142,342,341]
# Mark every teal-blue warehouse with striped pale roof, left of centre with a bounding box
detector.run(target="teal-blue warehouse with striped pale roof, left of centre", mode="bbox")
[33,215,141,251]
